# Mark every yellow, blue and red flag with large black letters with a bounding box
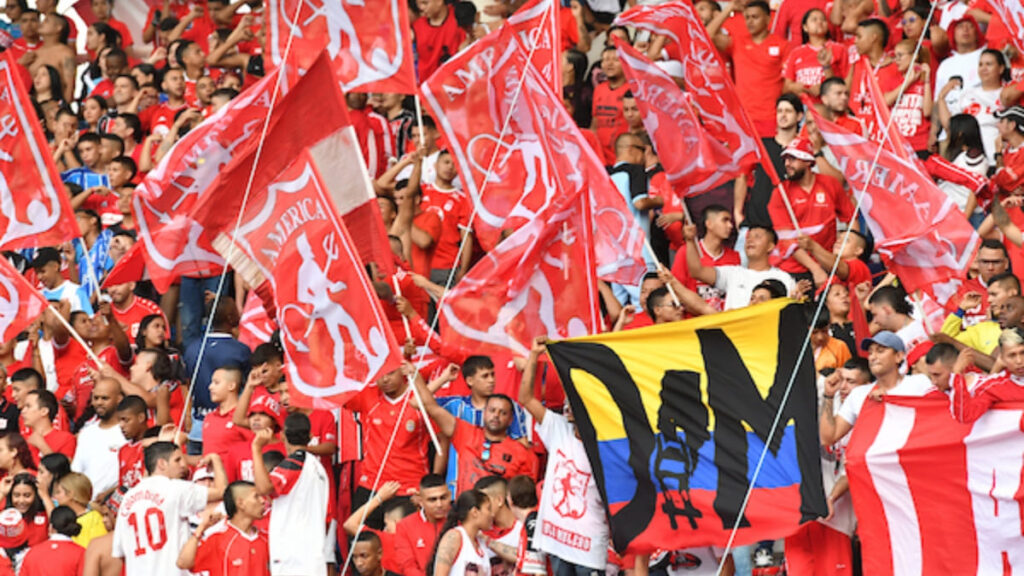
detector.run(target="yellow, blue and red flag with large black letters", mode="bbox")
[548,299,827,552]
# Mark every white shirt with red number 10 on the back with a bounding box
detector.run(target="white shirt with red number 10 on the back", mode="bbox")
[111,476,207,576]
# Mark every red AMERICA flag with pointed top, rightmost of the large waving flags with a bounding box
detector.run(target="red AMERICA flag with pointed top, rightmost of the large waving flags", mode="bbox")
[810,108,980,303]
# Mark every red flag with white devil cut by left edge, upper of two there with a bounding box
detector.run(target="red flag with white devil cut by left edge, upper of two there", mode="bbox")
[0,50,81,250]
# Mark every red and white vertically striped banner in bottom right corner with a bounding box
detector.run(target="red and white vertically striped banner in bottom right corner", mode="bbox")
[846,393,1024,576]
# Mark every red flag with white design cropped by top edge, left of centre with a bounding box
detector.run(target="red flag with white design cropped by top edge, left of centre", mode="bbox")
[266,0,416,94]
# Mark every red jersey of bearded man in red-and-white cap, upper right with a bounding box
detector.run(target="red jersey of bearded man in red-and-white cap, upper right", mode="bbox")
[768,174,853,273]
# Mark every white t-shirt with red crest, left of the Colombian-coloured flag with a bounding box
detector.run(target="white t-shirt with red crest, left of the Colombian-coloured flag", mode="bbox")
[534,410,608,571]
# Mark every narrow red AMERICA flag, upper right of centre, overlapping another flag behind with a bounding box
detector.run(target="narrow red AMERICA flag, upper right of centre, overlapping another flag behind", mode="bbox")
[615,42,738,196]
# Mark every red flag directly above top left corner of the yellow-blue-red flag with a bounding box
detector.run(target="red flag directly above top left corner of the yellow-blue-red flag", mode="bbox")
[441,194,600,356]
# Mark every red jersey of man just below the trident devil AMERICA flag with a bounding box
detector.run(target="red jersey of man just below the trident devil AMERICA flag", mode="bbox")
[345,386,429,495]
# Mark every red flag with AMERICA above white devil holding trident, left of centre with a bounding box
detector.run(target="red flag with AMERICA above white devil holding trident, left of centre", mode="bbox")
[221,150,401,408]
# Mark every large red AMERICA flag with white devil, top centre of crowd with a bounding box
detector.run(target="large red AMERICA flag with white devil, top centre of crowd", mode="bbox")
[421,26,646,285]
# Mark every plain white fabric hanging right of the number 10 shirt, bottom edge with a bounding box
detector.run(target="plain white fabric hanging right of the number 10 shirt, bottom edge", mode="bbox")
[268,453,328,576]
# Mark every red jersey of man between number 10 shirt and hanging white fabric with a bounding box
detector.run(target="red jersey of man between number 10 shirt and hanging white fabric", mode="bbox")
[193,522,270,576]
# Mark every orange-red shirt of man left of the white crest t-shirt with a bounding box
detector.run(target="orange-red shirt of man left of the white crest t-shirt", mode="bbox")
[452,419,538,494]
